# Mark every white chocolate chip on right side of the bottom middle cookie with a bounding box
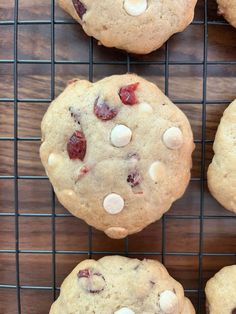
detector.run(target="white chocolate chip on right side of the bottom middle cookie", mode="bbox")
[160,290,178,314]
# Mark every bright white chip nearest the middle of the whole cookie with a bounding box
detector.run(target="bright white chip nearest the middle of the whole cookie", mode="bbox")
[111,124,132,147]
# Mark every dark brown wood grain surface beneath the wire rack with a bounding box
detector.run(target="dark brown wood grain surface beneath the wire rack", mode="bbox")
[0,0,236,314]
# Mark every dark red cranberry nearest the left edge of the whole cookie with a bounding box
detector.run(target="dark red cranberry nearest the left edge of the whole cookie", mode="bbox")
[67,131,87,160]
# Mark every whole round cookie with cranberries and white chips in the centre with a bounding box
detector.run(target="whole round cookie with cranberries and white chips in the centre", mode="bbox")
[40,74,194,238]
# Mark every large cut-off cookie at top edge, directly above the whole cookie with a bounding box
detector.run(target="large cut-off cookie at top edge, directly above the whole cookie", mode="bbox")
[59,0,197,54]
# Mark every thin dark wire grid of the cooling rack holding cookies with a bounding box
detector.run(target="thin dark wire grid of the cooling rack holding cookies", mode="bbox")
[0,0,236,314]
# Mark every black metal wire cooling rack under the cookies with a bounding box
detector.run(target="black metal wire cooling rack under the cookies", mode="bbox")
[0,0,236,314]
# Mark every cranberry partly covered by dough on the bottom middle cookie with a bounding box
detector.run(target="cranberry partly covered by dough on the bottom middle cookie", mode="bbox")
[77,268,106,293]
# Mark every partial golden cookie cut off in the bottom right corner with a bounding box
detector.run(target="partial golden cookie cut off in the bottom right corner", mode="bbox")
[205,265,236,314]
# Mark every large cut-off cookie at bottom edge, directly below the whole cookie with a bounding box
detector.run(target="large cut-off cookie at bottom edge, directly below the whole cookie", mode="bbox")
[50,256,195,314]
